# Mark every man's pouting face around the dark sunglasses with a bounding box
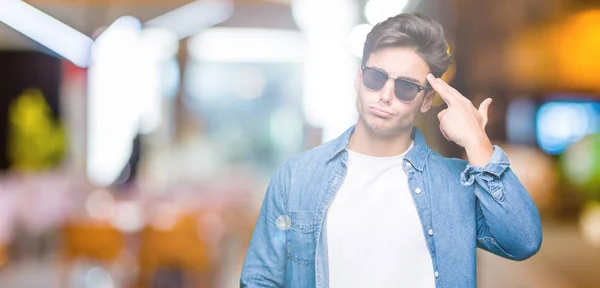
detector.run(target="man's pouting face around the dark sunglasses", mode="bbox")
[354,47,434,137]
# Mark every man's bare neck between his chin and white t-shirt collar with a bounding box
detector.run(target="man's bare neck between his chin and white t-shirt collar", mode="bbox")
[348,121,413,157]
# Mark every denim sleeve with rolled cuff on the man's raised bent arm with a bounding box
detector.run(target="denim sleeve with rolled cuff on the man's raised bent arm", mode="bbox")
[461,146,542,261]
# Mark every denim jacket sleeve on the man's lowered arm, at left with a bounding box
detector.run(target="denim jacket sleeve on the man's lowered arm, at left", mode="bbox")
[240,168,289,287]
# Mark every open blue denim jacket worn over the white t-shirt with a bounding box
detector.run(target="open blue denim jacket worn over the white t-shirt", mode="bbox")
[240,127,542,288]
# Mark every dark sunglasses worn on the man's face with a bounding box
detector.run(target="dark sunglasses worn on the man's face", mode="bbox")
[361,66,431,102]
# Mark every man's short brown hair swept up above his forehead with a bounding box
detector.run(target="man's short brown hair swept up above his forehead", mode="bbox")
[362,13,452,77]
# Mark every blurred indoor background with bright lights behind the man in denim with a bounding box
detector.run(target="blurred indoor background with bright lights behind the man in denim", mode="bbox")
[0,0,600,288]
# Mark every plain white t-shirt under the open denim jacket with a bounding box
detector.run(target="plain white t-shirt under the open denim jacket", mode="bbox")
[327,145,435,288]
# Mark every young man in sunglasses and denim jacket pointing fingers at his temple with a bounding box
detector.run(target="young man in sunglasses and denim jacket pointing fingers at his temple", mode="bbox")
[241,14,542,288]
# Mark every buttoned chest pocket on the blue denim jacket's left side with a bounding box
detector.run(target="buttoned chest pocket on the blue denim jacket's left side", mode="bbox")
[287,212,316,265]
